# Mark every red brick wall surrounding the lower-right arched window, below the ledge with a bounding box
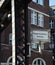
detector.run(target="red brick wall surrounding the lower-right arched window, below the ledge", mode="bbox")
[29,51,53,65]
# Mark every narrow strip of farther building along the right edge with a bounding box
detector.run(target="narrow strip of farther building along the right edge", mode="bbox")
[50,5,55,65]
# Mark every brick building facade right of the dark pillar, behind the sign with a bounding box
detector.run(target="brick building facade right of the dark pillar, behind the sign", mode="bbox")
[29,0,53,65]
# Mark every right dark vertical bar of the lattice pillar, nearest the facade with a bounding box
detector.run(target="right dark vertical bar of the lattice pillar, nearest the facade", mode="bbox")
[24,2,29,65]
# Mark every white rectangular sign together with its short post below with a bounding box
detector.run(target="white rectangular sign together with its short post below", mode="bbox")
[31,30,50,53]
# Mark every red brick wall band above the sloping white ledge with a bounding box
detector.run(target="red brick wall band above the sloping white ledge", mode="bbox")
[29,0,50,14]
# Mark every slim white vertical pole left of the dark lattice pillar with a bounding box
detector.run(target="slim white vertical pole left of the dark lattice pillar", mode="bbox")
[11,0,16,65]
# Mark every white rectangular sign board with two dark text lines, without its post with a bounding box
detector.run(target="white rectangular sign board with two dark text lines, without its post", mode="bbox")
[32,30,50,41]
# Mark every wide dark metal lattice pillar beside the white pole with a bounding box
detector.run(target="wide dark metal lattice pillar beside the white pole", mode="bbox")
[15,1,29,65]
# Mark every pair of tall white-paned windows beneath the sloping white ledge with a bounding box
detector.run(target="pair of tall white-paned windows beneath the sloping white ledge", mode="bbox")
[31,11,44,27]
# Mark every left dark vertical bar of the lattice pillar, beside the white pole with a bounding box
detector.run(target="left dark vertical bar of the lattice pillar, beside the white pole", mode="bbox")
[15,0,20,65]
